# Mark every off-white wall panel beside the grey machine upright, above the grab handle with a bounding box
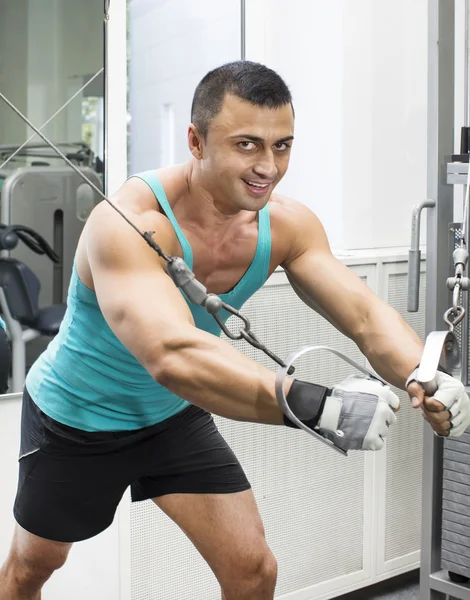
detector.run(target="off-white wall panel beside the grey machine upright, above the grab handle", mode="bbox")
[343,0,427,248]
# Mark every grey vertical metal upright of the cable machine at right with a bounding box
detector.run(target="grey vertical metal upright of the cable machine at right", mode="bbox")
[421,0,455,600]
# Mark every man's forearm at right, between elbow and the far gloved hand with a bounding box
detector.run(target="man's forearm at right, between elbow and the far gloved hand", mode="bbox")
[354,302,423,390]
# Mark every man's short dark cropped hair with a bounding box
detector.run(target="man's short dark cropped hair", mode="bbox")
[191,60,294,137]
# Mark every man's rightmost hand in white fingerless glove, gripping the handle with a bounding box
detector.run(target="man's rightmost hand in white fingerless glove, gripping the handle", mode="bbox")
[407,371,470,437]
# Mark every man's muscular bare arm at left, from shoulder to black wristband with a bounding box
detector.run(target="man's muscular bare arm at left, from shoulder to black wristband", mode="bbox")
[86,204,283,424]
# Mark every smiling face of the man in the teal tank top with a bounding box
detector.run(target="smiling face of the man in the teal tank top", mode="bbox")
[190,95,294,211]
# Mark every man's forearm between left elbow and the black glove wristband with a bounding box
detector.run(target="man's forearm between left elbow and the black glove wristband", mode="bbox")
[155,328,291,425]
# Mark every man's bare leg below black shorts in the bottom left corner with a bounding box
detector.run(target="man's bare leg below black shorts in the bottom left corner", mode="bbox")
[0,525,72,600]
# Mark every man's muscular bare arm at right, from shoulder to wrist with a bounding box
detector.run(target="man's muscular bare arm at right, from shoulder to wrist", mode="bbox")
[283,204,423,389]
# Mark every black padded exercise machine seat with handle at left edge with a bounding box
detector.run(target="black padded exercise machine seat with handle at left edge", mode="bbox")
[0,225,66,392]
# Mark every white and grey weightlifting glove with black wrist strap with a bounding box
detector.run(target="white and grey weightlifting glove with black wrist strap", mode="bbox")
[284,375,400,451]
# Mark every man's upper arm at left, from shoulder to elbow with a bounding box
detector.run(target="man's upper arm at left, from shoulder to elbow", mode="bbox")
[87,204,193,375]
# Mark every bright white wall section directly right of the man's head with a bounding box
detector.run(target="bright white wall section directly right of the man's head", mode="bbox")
[246,0,344,245]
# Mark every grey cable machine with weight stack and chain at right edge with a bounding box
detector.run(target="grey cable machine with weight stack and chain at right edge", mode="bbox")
[408,0,470,600]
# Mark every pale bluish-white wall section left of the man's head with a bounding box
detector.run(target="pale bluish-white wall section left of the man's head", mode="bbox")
[130,0,241,173]
